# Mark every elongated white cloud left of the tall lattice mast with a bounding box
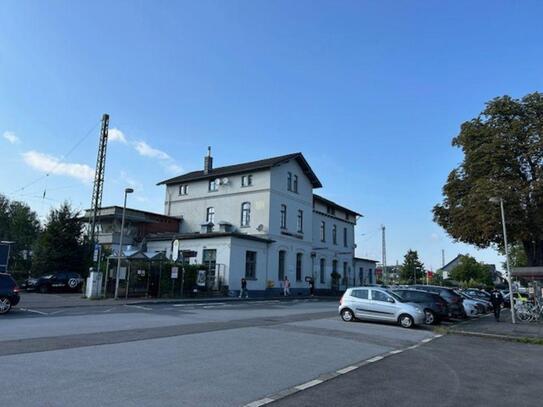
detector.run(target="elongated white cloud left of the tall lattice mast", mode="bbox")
[23,150,94,183]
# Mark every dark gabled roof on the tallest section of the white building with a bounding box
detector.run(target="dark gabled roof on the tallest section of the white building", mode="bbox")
[157,153,322,188]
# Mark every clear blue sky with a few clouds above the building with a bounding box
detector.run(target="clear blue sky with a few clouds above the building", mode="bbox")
[0,0,543,269]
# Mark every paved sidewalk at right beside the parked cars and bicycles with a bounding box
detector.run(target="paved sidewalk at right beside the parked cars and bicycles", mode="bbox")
[449,309,543,340]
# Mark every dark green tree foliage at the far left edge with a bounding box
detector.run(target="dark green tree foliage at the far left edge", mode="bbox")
[0,194,40,270]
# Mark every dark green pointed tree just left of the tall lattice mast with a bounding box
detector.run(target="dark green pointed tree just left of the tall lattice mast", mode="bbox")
[32,202,90,274]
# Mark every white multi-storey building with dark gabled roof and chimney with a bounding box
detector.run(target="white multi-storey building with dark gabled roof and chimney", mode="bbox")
[147,153,361,293]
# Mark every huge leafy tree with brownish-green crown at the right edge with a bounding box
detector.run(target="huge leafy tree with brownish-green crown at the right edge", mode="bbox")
[433,92,543,266]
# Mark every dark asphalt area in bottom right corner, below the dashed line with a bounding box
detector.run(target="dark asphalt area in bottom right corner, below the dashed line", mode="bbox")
[270,335,543,407]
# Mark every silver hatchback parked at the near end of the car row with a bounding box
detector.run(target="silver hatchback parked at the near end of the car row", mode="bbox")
[339,287,424,328]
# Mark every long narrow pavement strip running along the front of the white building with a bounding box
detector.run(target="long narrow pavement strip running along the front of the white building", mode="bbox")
[18,292,339,309]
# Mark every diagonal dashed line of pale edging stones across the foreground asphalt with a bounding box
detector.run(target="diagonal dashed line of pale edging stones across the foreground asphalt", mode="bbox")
[243,334,443,407]
